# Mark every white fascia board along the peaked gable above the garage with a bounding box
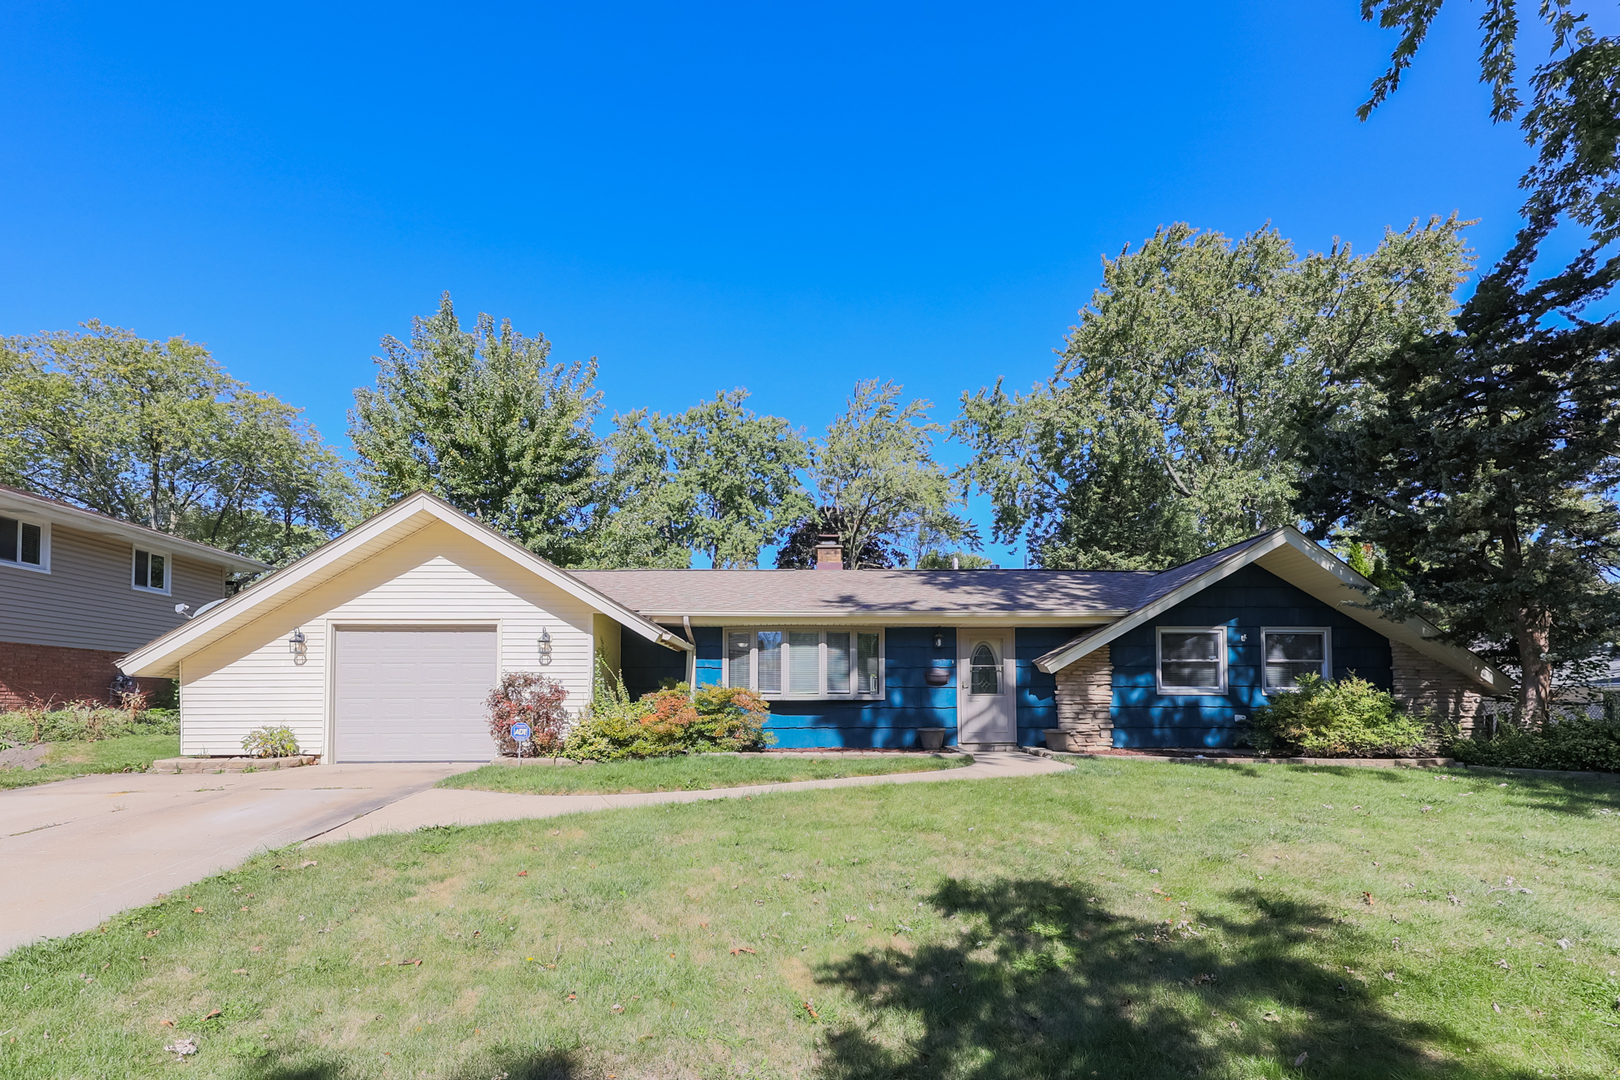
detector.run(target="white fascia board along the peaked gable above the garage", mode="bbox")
[118,492,693,677]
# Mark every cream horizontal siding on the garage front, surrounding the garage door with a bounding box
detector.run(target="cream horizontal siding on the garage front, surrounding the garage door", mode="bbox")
[180,523,595,755]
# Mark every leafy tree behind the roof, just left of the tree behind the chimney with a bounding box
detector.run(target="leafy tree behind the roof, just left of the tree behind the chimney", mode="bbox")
[604,389,810,568]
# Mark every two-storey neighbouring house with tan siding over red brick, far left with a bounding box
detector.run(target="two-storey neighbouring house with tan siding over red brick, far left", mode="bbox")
[0,484,269,709]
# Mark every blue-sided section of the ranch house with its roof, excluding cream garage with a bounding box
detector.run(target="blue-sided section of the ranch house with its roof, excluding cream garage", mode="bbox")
[573,528,1510,750]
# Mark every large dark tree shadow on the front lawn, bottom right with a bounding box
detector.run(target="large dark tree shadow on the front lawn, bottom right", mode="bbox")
[816,881,1528,1080]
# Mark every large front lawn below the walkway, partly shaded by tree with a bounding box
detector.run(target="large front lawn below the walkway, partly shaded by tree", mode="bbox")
[0,759,1620,1080]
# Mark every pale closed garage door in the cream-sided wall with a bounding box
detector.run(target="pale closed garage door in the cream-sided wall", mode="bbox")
[332,628,496,761]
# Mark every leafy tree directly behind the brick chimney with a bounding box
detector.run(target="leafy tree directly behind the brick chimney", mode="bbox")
[778,379,978,568]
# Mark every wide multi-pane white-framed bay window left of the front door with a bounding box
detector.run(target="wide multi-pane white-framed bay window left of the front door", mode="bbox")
[724,627,883,698]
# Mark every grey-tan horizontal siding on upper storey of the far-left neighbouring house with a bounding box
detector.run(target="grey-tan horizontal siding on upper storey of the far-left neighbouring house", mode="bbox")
[0,523,225,653]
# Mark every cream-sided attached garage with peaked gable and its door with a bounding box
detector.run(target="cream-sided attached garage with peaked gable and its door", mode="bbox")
[120,492,693,763]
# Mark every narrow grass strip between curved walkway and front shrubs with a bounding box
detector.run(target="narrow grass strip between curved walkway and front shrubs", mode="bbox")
[439,755,974,795]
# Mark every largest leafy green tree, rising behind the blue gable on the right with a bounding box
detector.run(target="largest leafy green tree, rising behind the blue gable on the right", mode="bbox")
[956,217,1469,570]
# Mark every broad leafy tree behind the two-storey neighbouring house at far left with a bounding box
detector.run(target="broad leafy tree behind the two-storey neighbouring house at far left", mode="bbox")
[0,321,353,563]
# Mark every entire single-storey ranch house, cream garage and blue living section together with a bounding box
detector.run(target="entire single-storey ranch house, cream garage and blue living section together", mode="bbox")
[122,494,1510,761]
